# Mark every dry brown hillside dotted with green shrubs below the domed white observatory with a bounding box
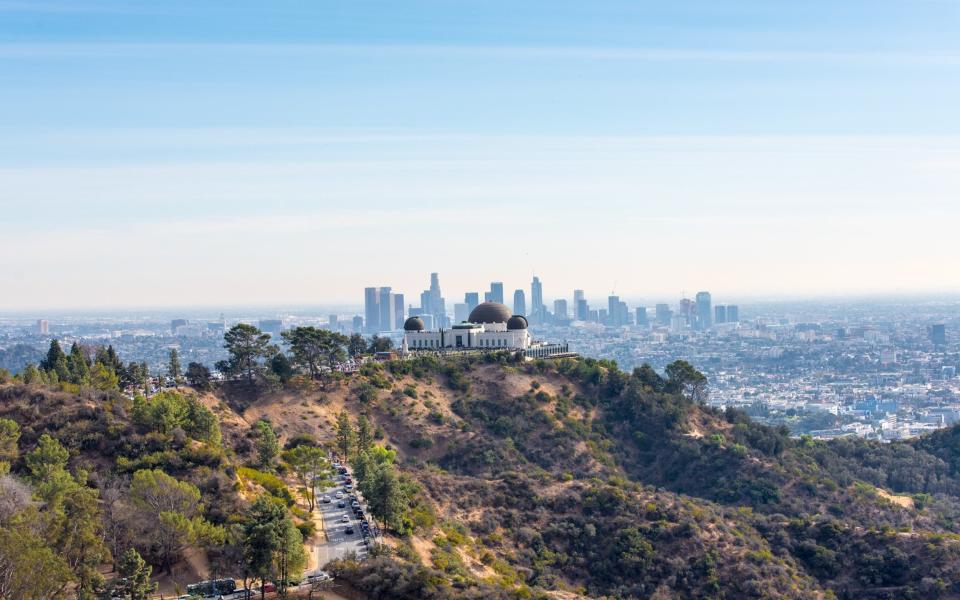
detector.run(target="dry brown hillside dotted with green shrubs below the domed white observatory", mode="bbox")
[0,354,960,598]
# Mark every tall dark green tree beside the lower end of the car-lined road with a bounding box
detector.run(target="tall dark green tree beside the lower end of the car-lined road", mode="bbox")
[243,496,306,598]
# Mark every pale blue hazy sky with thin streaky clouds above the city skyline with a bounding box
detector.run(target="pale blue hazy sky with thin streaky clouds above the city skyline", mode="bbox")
[0,0,960,309]
